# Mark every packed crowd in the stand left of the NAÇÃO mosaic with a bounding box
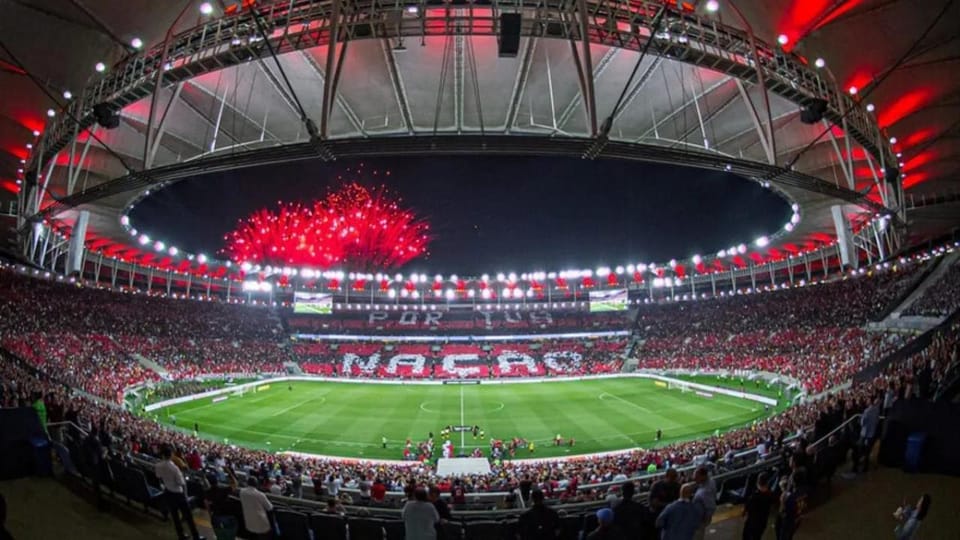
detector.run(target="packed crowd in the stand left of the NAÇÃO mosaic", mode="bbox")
[0,270,289,402]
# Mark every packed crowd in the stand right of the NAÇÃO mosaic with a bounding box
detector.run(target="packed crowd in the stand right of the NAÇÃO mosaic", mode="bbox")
[634,271,911,394]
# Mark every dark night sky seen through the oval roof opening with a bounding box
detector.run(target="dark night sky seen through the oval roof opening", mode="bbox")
[131,157,791,275]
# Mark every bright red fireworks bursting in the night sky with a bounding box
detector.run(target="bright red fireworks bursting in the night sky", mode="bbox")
[224,182,430,270]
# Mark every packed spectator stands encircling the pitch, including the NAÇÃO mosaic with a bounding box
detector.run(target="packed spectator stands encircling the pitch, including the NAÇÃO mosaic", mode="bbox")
[0,244,960,538]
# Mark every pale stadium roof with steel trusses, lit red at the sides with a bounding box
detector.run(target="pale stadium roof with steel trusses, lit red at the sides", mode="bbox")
[0,0,960,278]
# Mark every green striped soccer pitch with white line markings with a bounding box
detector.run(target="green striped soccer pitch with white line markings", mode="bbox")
[149,378,779,459]
